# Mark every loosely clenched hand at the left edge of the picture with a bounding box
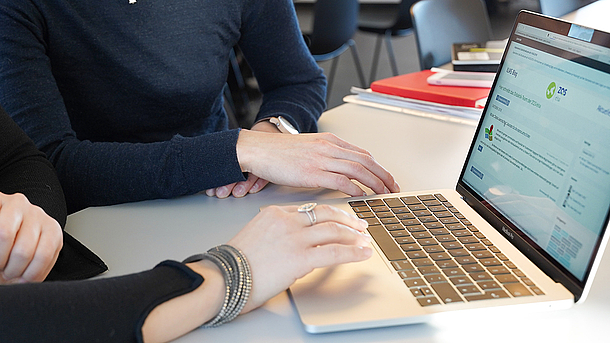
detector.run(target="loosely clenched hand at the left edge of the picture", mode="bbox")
[0,193,63,284]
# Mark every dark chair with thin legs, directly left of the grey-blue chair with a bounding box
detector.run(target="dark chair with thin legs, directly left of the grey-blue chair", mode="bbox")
[358,0,417,82]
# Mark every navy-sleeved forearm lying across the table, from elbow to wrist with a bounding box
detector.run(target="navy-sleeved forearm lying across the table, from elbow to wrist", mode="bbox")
[47,131,245,213]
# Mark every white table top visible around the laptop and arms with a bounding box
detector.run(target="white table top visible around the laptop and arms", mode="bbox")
[66,0,610,342]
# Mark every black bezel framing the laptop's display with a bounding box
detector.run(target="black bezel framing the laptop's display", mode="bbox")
[456,10,610,301]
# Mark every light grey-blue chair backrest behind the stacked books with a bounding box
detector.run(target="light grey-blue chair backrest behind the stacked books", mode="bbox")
[411,0,493,70]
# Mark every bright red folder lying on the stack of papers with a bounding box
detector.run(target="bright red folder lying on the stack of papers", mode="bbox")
[371,70,490,107]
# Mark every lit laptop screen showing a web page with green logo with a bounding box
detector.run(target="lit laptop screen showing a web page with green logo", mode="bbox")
[461,12,610,287]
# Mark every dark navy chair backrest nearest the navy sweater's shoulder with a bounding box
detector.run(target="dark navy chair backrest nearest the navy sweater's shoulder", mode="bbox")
[309,0,360,55]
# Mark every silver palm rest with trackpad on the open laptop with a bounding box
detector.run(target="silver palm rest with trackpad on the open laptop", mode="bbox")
[290,253,426,332]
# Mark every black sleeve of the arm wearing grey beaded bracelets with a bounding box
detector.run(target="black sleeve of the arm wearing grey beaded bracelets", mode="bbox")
[0,261,203,342]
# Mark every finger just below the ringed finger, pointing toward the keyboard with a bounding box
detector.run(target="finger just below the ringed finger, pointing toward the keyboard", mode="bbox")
[302,222,371,247]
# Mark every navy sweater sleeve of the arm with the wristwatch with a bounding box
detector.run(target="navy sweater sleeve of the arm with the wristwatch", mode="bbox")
[239,0,326,132]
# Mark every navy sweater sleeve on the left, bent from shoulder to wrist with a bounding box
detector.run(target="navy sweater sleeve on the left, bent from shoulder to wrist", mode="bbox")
[0,1,245,213]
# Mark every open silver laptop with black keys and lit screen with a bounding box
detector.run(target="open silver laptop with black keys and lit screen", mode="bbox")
[289,11,610,333]
